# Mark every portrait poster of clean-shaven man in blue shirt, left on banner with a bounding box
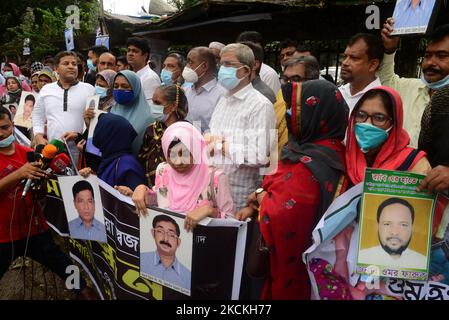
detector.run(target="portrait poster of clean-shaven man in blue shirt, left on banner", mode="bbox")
[58,175,107,242]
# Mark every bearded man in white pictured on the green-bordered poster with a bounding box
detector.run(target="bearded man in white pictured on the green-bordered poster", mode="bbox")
[358,198,427,270]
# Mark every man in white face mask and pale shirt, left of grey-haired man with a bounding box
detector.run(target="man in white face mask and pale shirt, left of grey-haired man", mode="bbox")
[182,47,226,133]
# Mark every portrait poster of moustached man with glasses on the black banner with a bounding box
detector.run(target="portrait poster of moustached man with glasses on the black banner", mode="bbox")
[140,209,193,296]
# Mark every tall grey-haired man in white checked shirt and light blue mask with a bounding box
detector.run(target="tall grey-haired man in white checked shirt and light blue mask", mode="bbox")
[206,43,277,210]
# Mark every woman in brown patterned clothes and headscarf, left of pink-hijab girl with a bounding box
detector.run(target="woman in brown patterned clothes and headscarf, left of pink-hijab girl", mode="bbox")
[139,84,188,186]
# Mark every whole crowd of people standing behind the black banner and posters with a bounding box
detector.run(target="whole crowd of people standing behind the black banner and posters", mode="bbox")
[0,14,449,299]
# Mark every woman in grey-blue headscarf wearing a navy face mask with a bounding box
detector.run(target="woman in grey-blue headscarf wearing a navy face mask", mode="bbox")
[111,70,153,156]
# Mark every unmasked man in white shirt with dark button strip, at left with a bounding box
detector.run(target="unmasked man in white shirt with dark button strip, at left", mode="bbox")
[32,51,95,160]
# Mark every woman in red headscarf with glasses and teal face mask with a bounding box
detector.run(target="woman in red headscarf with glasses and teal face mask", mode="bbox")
[346,86,430,185]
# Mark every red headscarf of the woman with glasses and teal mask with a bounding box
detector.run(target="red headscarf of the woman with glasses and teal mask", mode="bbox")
[346,86,426,184]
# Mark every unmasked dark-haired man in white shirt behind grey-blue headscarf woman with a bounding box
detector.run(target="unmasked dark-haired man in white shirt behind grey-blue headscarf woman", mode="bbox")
[126,37,161,102]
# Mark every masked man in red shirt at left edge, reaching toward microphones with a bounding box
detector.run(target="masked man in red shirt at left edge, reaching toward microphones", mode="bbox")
[0,107,94,299]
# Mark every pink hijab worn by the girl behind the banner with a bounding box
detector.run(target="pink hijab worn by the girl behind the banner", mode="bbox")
[162,121,209,213]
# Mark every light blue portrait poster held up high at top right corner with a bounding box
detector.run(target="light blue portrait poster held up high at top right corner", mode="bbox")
[391,0,437,35]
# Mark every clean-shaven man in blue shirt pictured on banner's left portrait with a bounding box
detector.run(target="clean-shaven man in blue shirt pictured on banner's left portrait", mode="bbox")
[69,180,107,242]
